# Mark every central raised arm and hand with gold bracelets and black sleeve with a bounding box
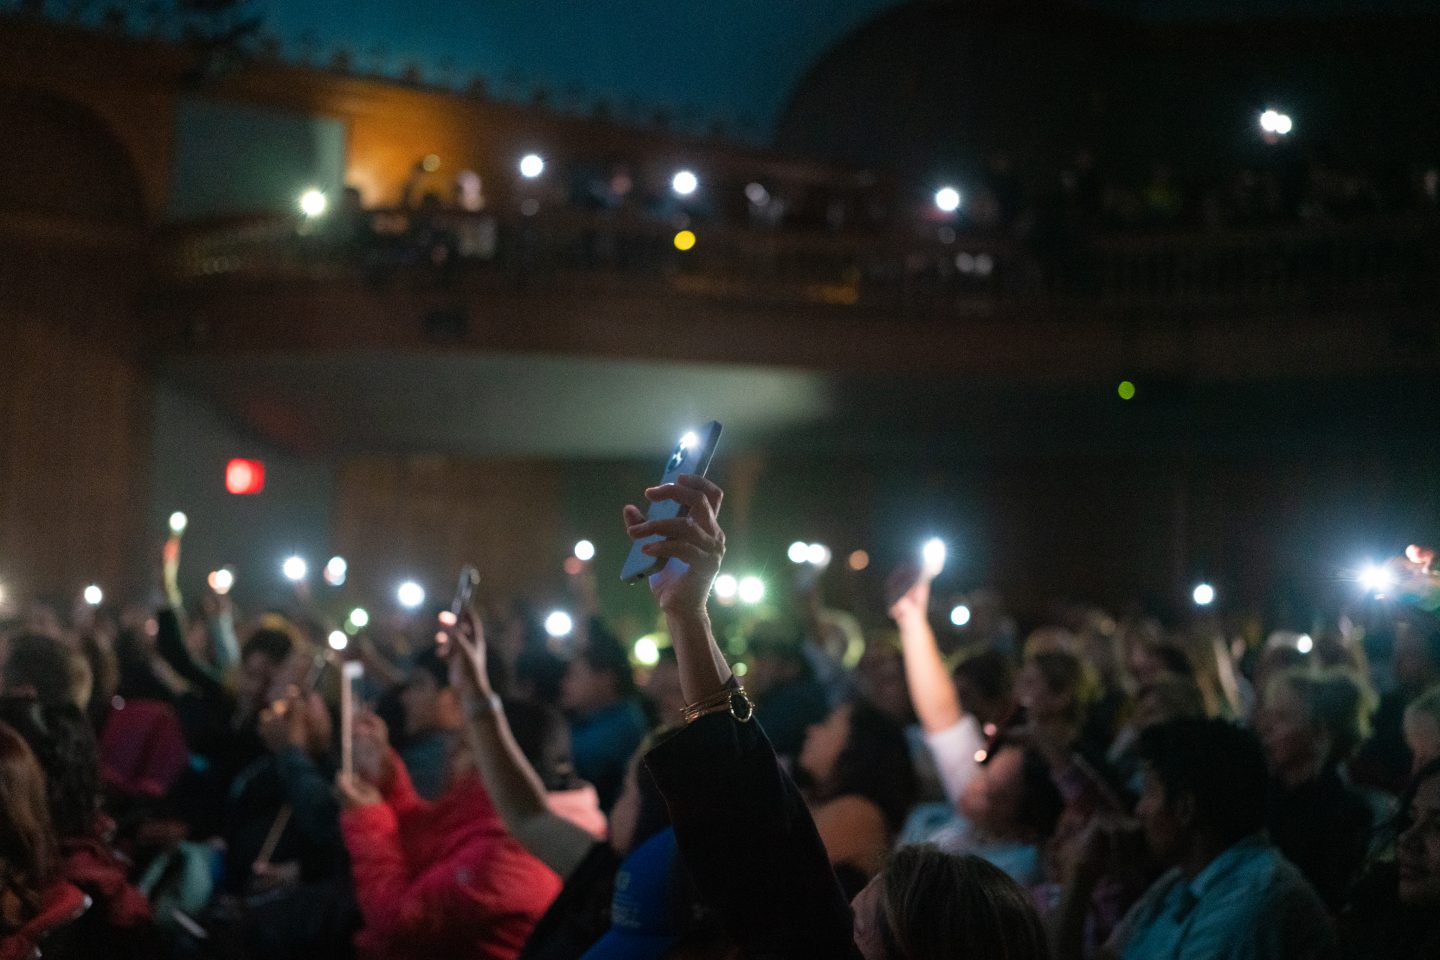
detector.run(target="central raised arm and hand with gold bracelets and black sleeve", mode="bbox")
[625,476,860,959]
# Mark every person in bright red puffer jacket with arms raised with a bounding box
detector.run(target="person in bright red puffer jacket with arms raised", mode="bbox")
[338,699,560,960]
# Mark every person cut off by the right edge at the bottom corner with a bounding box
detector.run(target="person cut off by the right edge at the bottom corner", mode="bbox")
[1341,760,1440,960]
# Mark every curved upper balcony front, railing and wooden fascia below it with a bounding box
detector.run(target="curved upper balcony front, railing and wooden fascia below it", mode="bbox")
[151,197,1440,376]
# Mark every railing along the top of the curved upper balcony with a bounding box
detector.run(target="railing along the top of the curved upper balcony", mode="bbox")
[157,209,1440,317]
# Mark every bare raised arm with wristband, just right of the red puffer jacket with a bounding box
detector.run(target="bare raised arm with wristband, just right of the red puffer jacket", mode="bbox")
[448,607,596,877]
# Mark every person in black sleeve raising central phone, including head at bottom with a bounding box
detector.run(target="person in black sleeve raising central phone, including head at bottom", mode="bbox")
[625,476,1047,960]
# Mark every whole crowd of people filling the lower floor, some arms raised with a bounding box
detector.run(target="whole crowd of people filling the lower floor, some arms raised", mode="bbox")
[0,476,1440,960]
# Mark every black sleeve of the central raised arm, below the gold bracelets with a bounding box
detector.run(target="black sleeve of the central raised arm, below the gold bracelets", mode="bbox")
[645,714,860,960]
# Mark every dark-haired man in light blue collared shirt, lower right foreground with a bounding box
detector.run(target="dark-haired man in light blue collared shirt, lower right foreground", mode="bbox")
[1057,720,1335,960]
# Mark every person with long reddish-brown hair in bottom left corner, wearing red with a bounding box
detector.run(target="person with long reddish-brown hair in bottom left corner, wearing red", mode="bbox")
[0,724,95,960]
